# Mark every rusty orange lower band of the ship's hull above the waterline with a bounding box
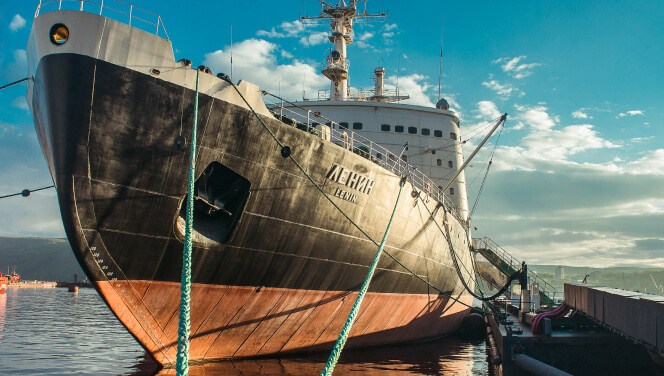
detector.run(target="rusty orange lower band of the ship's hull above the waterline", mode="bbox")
[97,281,470,362]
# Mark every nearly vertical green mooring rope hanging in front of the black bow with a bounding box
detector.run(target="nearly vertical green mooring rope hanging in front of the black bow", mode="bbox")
[176,70,199,376]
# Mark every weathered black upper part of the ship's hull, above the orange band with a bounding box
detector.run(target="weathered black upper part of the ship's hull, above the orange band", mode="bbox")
[33,54,466,294]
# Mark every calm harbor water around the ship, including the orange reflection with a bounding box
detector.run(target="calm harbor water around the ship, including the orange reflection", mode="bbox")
[0,288,489,376]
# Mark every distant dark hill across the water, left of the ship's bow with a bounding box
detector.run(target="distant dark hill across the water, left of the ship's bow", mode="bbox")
[0,237,85,281]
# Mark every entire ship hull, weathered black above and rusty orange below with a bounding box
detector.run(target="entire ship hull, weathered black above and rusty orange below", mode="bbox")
[28,12,472,365]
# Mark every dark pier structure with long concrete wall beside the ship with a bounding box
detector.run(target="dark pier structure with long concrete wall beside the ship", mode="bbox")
[485,284,664,376]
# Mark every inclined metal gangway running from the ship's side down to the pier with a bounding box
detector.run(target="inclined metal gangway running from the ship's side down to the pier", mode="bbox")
[473,237,556,306]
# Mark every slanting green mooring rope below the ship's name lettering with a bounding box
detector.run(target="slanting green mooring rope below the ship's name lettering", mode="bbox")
[321,178,406,376]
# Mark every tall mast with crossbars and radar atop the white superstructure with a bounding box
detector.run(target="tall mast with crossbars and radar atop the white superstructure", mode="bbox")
[300,0,386,101]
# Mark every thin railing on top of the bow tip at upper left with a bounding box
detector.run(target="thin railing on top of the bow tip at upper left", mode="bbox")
[35,0,170,40]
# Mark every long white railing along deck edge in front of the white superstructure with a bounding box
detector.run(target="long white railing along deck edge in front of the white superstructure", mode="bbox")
[262,91,468,227]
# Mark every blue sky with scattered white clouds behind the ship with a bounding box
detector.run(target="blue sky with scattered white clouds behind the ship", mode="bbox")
[0,0,664,267]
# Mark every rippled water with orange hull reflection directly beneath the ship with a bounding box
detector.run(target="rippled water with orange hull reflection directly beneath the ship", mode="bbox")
[139,337,489,376]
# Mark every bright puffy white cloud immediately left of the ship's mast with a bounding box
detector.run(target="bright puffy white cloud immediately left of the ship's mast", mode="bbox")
[203,38,329,100]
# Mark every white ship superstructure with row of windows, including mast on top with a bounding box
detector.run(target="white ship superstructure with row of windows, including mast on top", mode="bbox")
[282,0,468,220]
